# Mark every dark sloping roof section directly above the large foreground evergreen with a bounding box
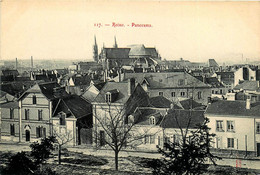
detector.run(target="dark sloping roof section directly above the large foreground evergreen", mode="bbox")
[161,109,204,129]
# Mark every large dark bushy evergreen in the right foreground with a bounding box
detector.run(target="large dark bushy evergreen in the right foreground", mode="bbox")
[154,118,220,175]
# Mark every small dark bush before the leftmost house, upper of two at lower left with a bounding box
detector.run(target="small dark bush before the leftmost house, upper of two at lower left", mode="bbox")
[30,136,56,164]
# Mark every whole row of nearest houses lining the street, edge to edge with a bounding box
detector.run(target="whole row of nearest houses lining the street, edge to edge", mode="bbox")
[1,68,260,155]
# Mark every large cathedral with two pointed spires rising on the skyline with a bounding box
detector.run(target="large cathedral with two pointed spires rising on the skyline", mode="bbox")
[93,37,161,70]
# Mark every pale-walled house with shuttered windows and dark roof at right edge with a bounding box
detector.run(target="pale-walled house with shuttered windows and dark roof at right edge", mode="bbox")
[205,99,260,156]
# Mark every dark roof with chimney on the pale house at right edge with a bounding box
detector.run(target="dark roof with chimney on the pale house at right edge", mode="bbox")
[206,100,260,117]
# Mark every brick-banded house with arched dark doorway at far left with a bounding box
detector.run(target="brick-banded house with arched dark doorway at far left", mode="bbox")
[1,82,68,142]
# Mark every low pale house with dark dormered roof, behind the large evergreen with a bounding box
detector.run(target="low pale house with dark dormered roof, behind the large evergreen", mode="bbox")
[131,107,204,151]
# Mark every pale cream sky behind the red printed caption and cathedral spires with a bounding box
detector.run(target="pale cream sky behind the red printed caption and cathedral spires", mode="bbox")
[0,0,260,62]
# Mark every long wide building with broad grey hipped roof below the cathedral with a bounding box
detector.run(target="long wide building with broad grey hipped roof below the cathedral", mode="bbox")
[123,72,211,105]
